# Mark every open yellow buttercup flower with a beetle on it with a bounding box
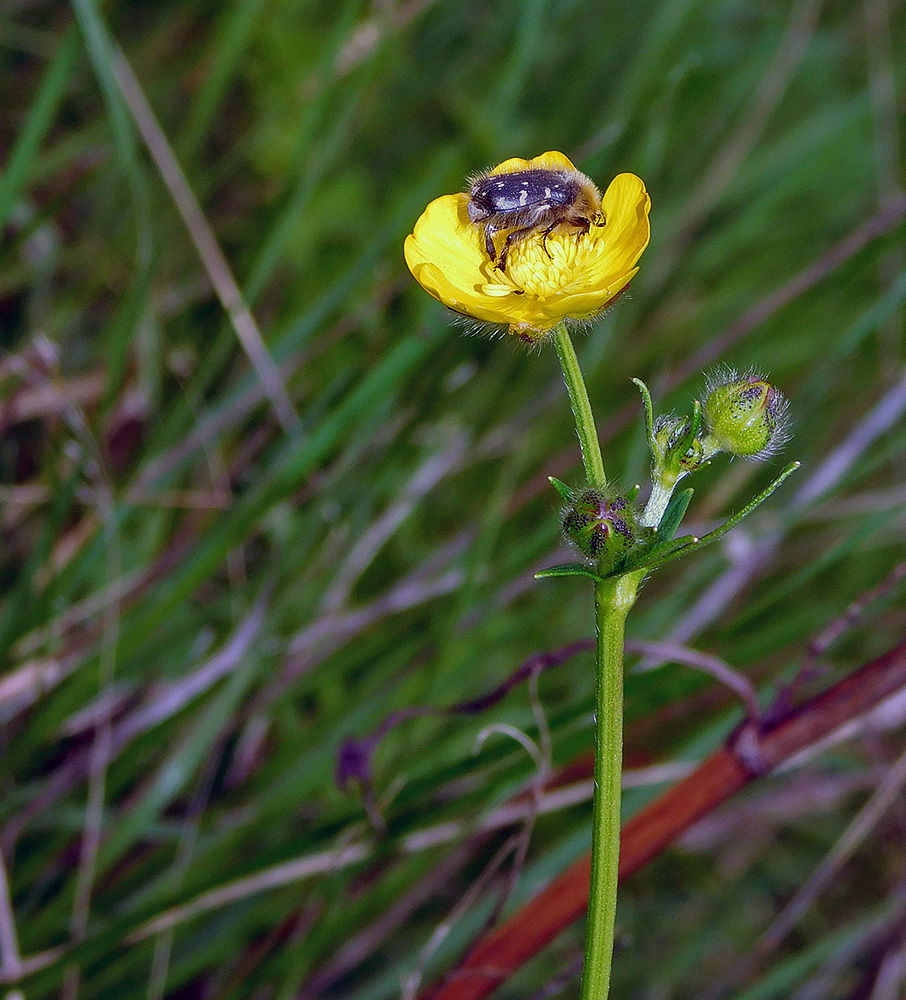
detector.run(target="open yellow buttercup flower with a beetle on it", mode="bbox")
[405,152,651,342]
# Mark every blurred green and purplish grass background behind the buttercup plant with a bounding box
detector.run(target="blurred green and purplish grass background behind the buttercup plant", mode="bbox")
[0,0,906,1000]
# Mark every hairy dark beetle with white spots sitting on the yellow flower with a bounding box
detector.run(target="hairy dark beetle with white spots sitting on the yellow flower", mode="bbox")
[468,167,604,271]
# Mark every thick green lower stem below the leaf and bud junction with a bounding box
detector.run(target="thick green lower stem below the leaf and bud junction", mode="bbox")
[582,570,645,1000]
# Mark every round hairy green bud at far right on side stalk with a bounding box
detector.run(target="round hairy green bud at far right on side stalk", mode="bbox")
[704,370,787,459]
